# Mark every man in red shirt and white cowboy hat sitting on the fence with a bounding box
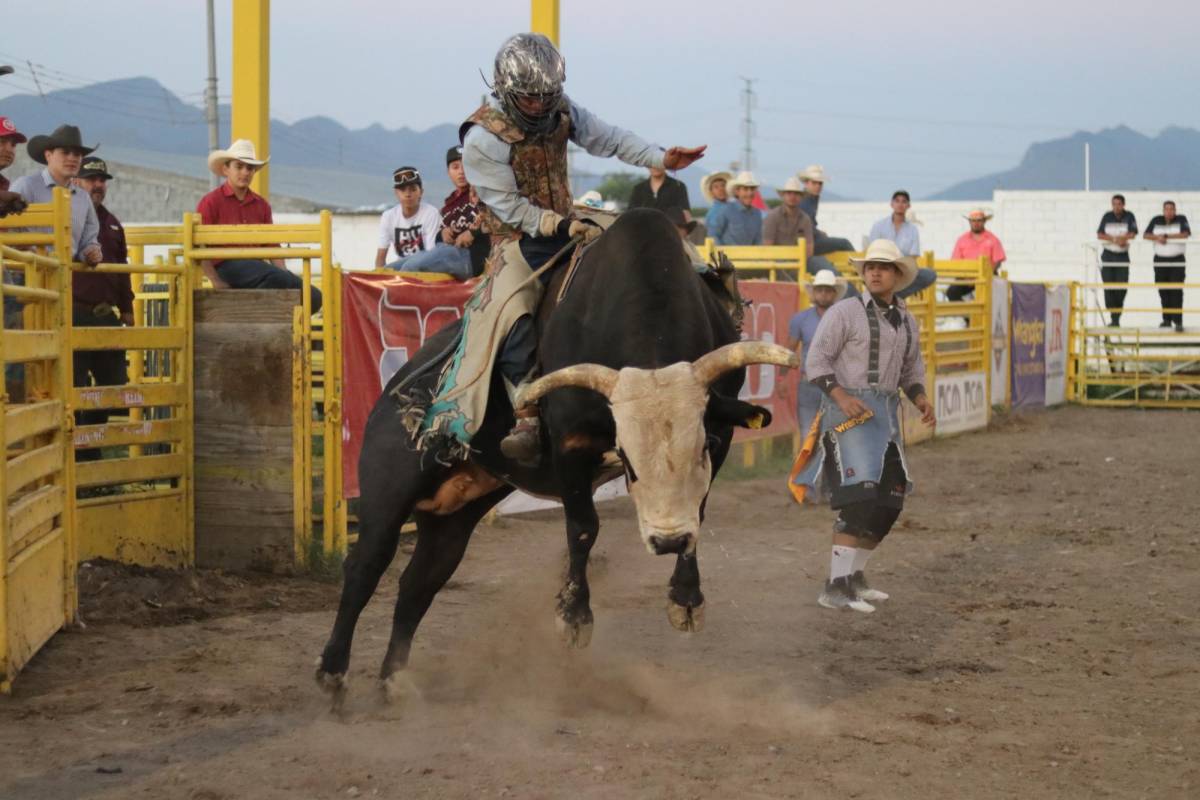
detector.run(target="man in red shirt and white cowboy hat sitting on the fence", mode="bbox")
[196,139,322,314]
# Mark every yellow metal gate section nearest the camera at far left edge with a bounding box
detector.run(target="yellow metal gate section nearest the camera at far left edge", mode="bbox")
[0,190,78,693]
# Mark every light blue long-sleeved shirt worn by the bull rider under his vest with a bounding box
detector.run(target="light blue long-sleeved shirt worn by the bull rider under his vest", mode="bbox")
[462,97,664,236]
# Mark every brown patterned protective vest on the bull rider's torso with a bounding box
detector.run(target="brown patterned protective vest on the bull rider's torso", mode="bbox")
[458,98,572,239]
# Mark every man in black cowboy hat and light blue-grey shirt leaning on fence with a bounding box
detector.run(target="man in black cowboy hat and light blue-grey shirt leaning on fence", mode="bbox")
[12,125,101,266]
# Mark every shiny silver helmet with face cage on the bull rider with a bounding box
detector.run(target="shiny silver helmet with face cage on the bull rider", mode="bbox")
[492,34,566,133]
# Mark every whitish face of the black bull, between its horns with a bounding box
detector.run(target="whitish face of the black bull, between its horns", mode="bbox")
[608,363,713,553]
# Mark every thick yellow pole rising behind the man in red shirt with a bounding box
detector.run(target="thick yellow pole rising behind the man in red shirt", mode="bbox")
[229,0,271,199]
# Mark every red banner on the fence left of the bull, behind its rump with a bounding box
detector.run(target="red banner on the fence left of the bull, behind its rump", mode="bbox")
[342,272,475,498]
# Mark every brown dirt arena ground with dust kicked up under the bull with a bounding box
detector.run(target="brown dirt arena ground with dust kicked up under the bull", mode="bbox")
[0,408,1200,800]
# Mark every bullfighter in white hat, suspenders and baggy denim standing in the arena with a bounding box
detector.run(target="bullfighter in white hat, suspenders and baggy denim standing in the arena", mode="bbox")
[788,239,934,613]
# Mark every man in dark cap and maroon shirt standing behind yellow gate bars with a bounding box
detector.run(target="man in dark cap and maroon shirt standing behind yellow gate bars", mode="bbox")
[71,156,133,462]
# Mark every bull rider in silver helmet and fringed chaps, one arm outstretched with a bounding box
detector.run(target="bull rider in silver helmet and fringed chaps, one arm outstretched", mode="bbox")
[415,34,704,464]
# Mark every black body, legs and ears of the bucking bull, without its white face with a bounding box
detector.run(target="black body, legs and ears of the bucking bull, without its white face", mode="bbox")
[317,210,796,697]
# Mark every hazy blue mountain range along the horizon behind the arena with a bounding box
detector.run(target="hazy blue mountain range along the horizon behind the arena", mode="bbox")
[0,78,1200,209]
